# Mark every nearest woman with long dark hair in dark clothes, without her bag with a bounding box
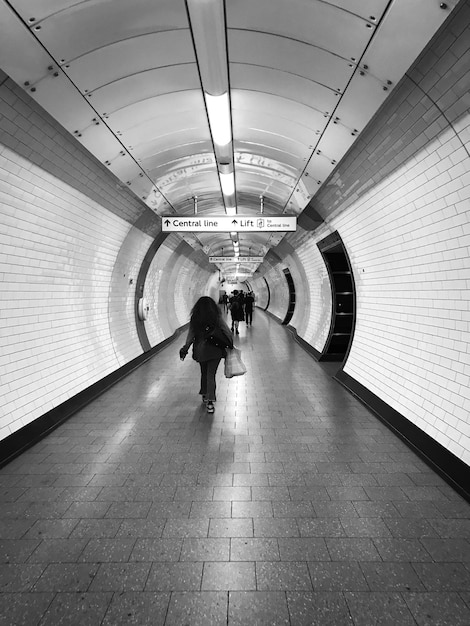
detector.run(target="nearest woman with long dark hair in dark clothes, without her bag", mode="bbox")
[180,296,233,413]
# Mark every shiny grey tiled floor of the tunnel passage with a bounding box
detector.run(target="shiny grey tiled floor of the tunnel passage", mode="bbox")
[0,312,470,626]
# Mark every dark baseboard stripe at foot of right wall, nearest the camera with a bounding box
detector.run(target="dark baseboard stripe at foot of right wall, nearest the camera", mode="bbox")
[334,370,470,501]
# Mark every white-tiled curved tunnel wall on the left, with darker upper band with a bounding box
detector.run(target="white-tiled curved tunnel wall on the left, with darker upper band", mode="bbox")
[0,73,211,440]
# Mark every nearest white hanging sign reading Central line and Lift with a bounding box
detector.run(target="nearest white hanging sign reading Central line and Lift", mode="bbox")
[162,215,297,233]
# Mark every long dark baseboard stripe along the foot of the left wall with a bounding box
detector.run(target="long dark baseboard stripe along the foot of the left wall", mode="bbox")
[0,324,187,467]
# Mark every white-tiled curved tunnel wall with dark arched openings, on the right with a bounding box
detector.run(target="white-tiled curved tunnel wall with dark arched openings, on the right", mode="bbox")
[258,2,470,465]
